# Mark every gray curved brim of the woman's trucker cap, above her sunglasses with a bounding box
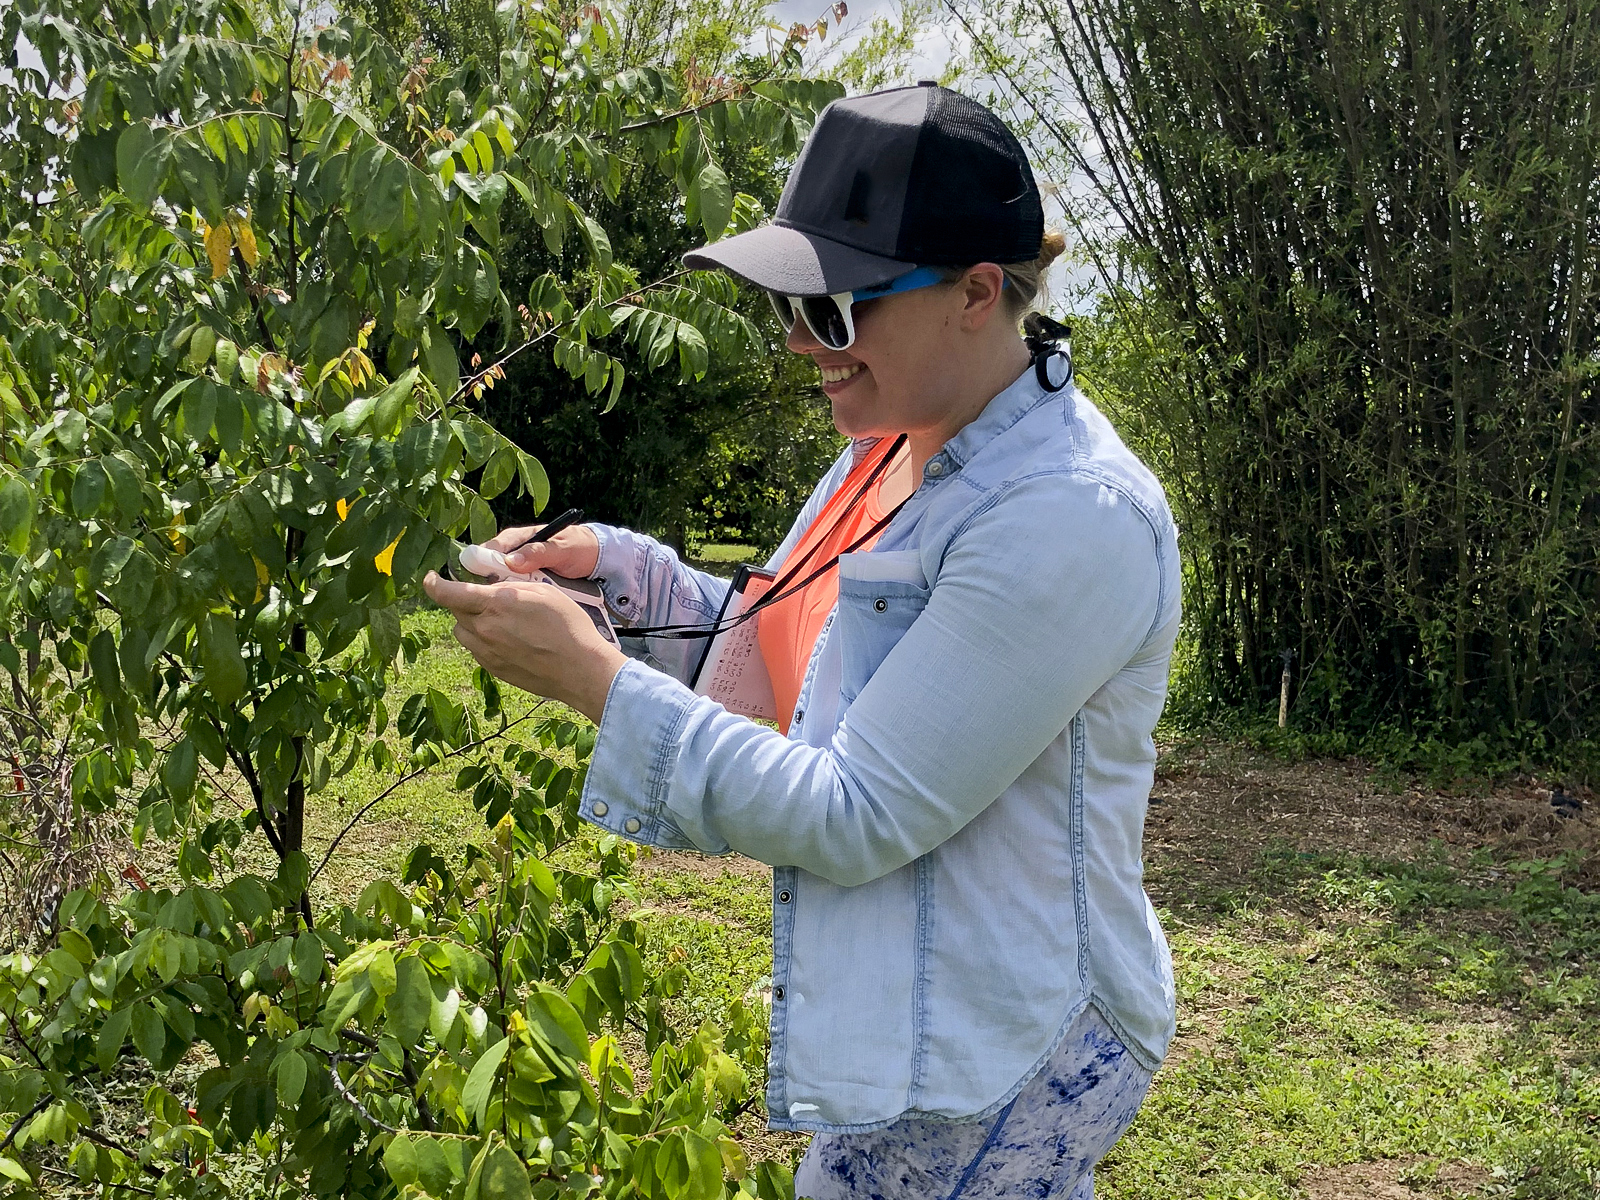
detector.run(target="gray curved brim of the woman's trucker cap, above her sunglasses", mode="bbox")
[683,226,917,296]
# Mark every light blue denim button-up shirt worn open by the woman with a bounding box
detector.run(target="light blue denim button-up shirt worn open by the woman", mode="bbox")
[582,361,1179,1133]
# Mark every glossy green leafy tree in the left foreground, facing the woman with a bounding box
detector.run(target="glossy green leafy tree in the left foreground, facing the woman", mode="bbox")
[0,0,837,1200]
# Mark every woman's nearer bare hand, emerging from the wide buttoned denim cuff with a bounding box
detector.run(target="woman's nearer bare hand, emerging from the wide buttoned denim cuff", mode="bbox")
[422,571,627,725]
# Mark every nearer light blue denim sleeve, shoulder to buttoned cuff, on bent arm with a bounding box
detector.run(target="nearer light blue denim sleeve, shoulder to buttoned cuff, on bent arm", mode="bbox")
[581,475,1171,886]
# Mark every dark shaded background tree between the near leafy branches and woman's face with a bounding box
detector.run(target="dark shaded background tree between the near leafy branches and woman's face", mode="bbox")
[350,0,843,547]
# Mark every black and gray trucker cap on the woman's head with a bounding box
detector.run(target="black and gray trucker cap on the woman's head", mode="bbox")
[683,83,1045,296]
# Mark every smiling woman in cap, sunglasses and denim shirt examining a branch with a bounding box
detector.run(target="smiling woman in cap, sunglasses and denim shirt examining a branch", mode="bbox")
[427,85,1179,1200]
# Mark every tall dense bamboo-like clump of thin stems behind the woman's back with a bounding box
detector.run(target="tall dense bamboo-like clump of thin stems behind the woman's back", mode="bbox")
[962,0,1600,750]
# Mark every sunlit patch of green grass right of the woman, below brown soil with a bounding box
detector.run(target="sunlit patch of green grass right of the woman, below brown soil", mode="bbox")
[1101,848,1600,1200]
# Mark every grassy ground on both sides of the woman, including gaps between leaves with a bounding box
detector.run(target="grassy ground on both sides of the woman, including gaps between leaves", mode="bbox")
[256,620,1600,1200]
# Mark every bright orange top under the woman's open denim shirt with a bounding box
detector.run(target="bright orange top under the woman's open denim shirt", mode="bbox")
[755,438,904,733]
